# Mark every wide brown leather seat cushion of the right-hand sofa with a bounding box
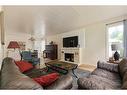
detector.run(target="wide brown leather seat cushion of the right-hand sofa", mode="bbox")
[78,75,121,89]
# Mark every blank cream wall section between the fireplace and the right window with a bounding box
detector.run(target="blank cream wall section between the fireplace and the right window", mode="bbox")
[83,23,106,65]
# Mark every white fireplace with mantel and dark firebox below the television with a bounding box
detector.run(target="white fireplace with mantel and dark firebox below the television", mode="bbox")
[61,48,80,64]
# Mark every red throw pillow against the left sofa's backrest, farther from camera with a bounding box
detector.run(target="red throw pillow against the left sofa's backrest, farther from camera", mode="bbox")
[15,61,33,73]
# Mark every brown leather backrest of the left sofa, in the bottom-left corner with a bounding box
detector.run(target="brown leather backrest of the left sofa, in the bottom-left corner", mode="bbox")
[0,58,43,90]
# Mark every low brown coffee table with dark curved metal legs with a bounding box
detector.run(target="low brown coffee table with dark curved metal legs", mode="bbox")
[45,60,78,78]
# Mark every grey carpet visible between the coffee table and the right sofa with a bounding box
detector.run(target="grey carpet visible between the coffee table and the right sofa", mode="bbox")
[70,68,90,89]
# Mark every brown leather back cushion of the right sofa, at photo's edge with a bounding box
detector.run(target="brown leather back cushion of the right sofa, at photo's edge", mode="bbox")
[118,58,127,78]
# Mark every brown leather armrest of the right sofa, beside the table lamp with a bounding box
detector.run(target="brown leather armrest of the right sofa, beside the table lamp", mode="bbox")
[97,61,118,72]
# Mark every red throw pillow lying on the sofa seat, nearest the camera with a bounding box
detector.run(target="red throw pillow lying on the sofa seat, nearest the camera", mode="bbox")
[33,73,59,86]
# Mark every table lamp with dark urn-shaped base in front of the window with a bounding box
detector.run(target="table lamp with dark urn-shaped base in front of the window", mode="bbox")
[111,43,120,61]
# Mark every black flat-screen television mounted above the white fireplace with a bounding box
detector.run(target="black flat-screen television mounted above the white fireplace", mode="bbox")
[63,36,78,47]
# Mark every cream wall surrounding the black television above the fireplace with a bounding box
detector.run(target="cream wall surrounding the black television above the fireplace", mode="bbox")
[46,28,85,62]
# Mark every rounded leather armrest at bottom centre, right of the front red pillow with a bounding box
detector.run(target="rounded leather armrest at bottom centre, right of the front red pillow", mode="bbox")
[45,75,73,90]
